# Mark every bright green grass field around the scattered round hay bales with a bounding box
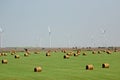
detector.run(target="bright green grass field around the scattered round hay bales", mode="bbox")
[0,51,120,80]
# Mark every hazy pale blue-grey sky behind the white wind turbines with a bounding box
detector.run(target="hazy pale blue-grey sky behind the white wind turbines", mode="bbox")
[0,0,120,47]
